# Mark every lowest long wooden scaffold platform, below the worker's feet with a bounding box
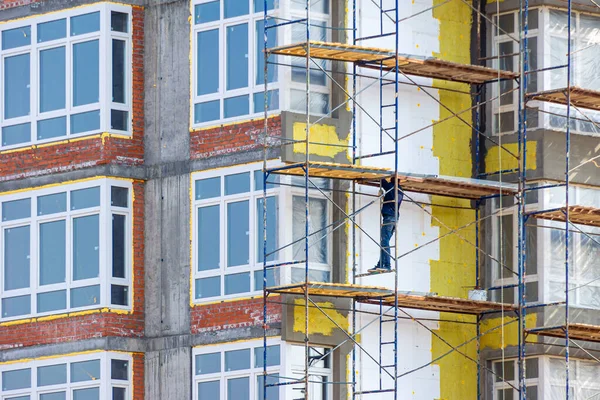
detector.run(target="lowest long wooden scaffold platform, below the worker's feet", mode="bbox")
[267,282,517,315]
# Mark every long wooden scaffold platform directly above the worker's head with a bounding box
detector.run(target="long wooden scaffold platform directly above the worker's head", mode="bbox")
[272,161,517,200]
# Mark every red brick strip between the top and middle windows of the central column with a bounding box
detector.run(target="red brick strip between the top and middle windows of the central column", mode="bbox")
[190,115,281,159]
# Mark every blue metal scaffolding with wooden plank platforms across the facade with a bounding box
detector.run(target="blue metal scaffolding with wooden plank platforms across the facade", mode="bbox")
[262,0,600,400]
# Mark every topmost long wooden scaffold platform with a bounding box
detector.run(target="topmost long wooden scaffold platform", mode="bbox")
[267,41,519,84]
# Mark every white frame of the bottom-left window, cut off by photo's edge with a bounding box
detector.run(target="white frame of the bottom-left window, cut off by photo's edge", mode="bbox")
[0,351,133,400]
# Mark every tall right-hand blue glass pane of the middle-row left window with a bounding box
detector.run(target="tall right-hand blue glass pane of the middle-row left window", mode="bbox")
[73,214,100,281]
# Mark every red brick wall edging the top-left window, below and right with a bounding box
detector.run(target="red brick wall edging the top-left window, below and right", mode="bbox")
[0,6,144,182]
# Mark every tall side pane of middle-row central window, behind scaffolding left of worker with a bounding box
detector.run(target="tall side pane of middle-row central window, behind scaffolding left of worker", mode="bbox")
[293,196,327,263]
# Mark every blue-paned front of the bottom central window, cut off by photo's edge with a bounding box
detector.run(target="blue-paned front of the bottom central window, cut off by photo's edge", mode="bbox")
[193,340,283,400]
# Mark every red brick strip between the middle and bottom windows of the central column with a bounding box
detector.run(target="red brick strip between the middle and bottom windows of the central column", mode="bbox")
[191,297,281,334]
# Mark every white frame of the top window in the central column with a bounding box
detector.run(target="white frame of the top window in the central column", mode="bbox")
[190,0,281,128]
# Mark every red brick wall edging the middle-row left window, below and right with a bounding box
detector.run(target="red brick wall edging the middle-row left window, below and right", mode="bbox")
[0,182,144,349]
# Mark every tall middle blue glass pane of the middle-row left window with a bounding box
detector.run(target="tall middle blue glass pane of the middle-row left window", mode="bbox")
[40,220,67,285]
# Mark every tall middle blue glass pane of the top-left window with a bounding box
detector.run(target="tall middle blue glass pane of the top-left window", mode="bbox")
[40,46,66,112]
